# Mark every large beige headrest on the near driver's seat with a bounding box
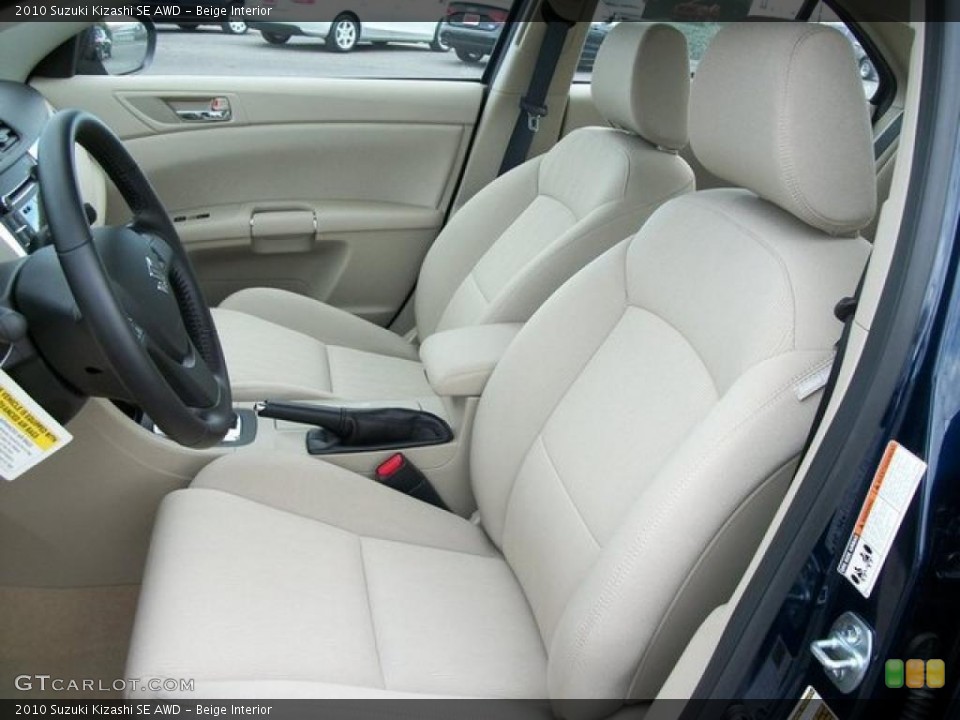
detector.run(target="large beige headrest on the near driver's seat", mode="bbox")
[690,22,877,235]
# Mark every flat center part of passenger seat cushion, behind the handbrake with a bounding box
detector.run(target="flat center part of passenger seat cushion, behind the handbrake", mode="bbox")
[212,306,434,400]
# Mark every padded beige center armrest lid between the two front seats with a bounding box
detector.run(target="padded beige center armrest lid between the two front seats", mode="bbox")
[420,323,523,397]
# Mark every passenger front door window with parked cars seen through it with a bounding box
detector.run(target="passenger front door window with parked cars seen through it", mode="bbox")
[130,0,513,80]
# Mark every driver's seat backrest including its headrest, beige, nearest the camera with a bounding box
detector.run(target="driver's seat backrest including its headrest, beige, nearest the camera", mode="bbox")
[471,23,875,699]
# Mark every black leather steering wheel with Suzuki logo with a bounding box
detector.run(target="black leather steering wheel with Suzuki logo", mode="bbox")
[38,110,233,447]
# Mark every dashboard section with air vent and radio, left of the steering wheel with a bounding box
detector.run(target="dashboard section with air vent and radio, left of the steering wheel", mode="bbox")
[0,82,50,260]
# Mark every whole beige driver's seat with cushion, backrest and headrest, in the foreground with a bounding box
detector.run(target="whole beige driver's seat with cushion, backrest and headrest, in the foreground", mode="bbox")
[127,23,875,711]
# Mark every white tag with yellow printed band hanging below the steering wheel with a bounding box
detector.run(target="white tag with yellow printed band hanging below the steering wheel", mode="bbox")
[0,370,73,480]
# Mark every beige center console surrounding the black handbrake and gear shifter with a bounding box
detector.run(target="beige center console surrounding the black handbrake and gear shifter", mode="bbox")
[3,320,524,585]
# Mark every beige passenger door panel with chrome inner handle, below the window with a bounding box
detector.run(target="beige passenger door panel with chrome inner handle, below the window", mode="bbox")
[35,77,483,324]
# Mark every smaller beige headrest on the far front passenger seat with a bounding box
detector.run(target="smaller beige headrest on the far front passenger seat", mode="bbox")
[591,22,690,150]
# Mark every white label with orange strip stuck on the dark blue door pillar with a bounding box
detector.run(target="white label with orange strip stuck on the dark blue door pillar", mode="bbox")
[837,442,927,598]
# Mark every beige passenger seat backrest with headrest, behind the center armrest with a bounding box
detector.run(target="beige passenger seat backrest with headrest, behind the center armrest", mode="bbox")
[416,23,694,340]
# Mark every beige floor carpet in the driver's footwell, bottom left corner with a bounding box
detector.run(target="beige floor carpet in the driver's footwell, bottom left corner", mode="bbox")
[0,585,140,699]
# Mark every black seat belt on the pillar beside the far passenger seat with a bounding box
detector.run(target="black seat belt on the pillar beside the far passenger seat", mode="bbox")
[497,2,573,175]
